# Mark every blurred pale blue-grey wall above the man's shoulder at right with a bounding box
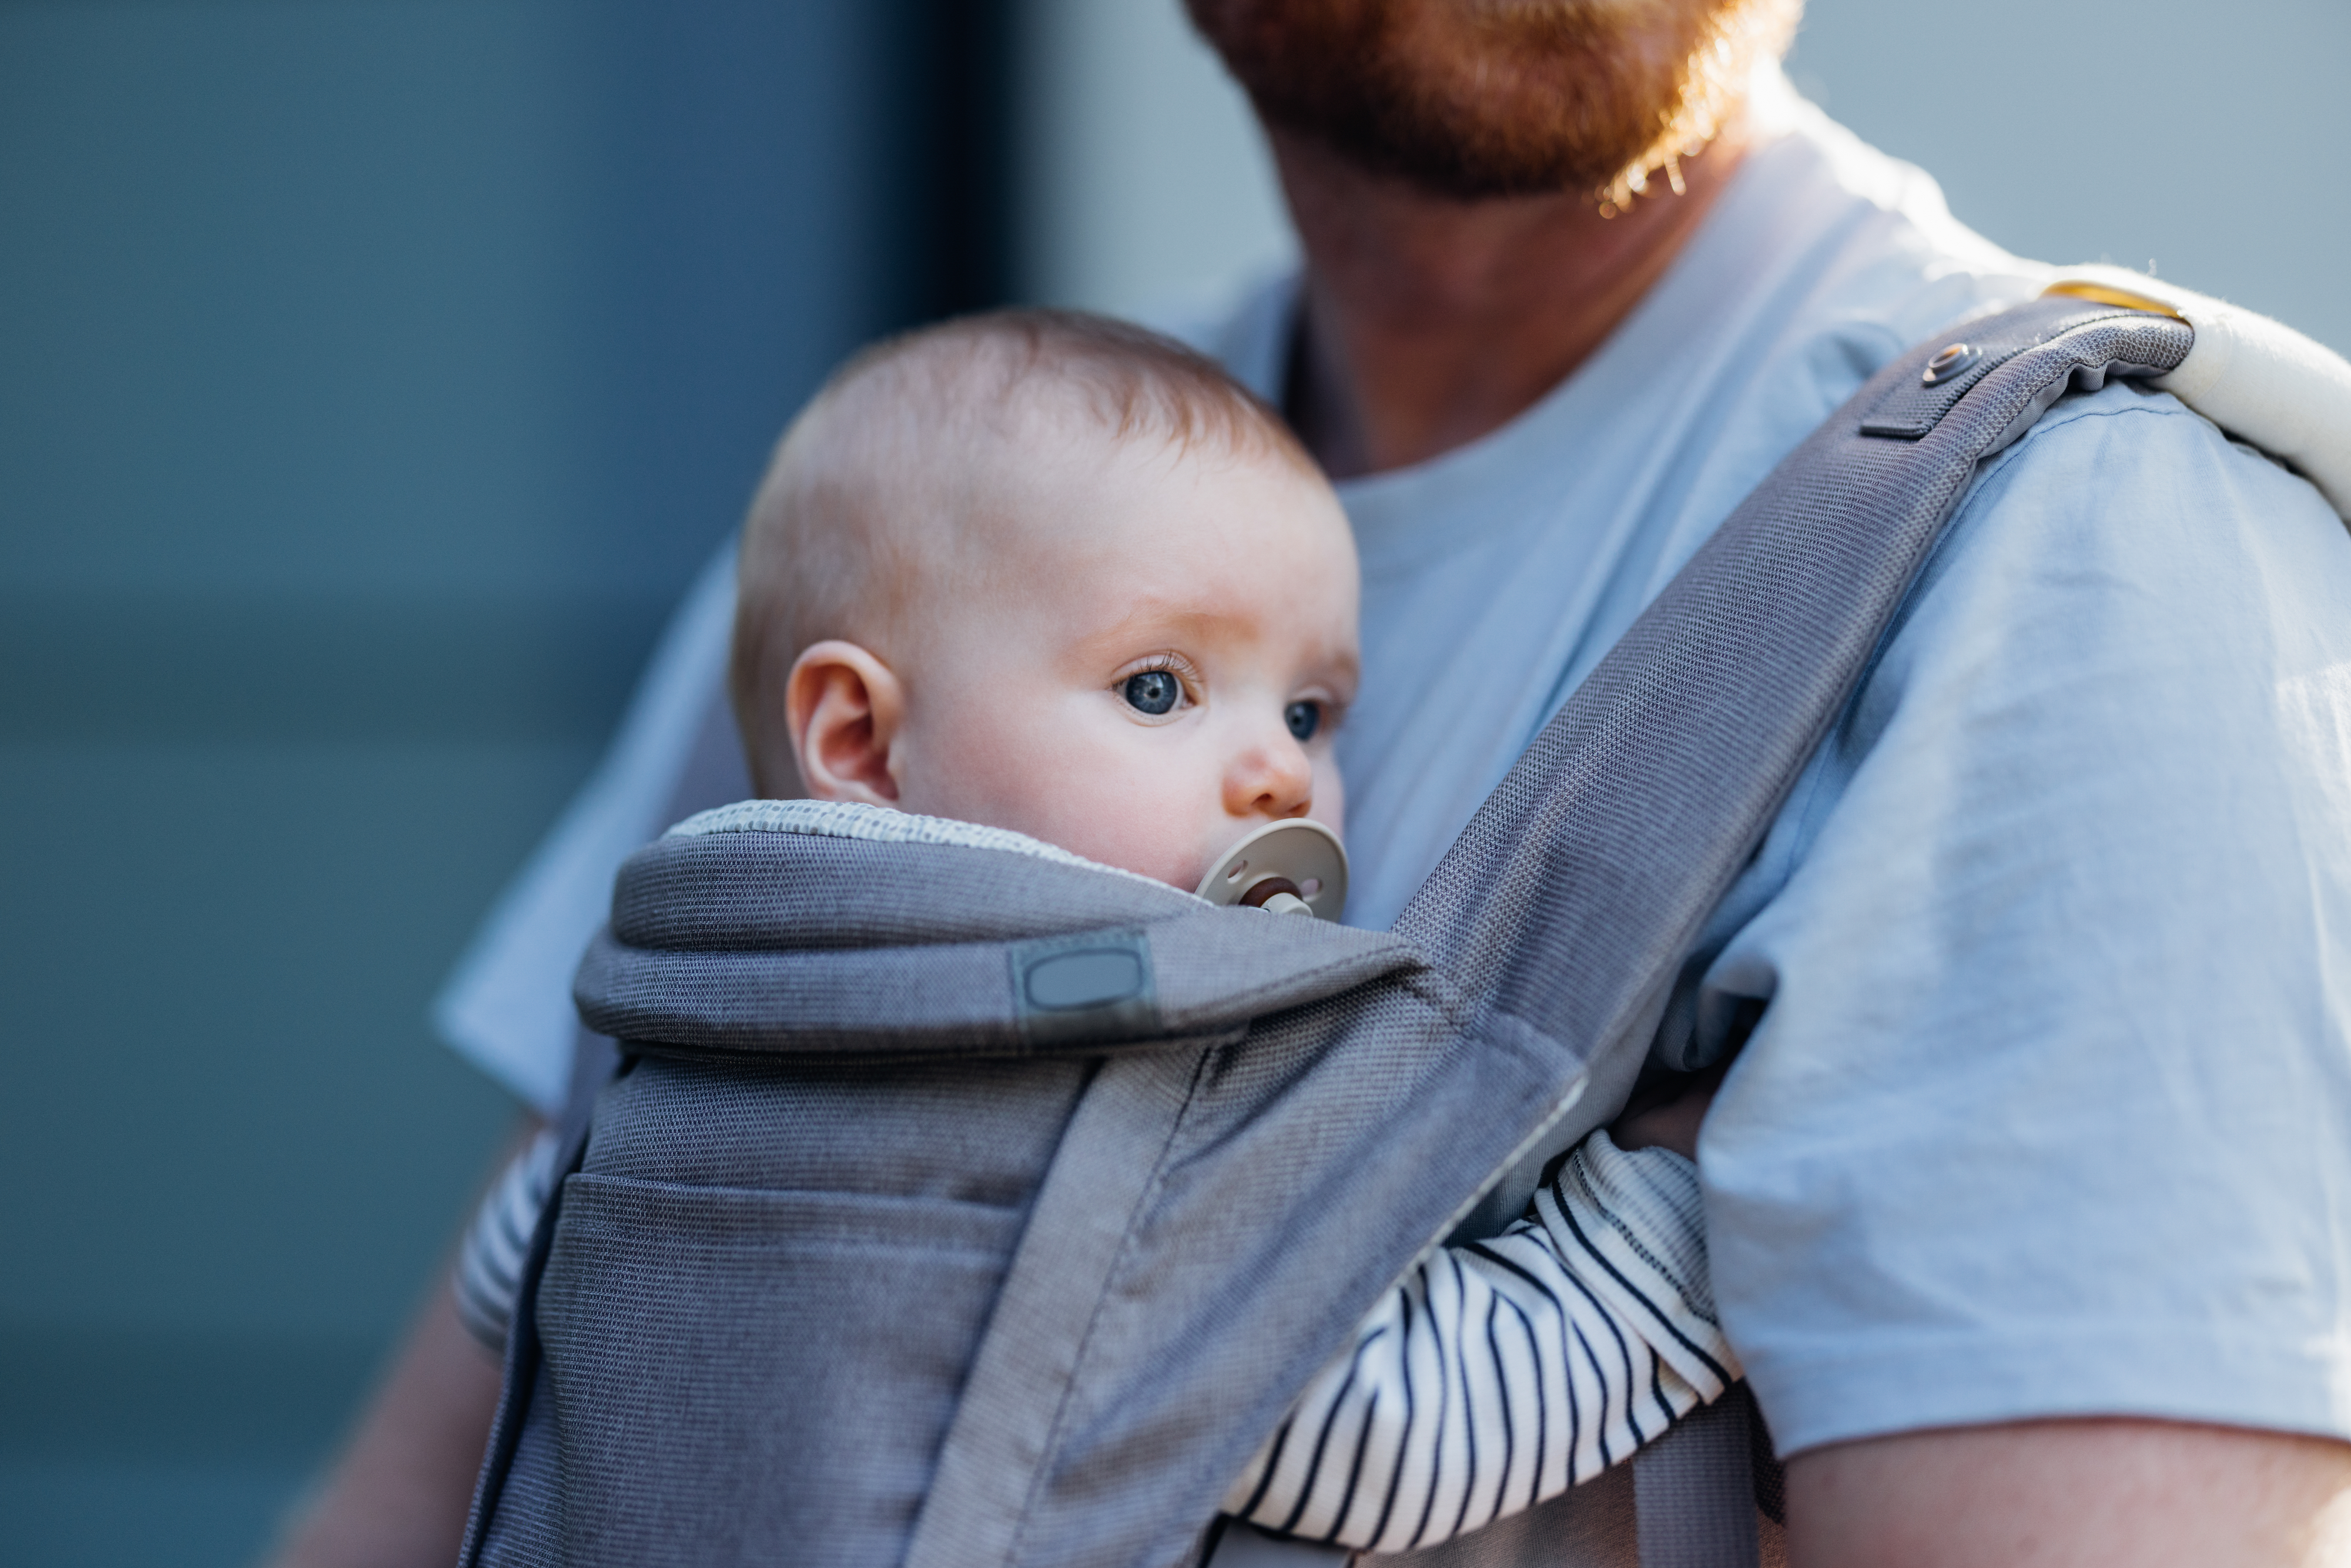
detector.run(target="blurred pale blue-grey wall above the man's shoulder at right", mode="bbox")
[1789,0,2351,350]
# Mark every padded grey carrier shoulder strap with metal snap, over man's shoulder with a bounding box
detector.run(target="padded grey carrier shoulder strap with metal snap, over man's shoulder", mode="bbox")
[1204,296,2193,1568]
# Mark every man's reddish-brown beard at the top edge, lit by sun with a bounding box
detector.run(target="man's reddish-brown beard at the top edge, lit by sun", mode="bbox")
[1185,0,1801,205]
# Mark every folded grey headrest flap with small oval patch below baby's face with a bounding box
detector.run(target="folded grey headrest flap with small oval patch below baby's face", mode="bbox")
[574,802,1425,1058]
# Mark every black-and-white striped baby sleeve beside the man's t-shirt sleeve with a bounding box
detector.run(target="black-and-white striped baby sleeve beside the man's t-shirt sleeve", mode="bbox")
[1225,1133,1740,1552]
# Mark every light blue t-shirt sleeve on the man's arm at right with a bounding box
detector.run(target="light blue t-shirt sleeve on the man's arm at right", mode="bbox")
[1690,386,2351,1453]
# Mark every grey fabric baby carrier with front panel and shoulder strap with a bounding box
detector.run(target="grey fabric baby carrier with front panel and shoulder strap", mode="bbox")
[463,301,2191,1568]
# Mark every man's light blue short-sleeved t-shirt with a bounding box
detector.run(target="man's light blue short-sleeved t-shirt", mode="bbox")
[437,86,2351,1450]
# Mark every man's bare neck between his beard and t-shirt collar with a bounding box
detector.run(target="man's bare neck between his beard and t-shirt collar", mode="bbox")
[1272,129,1744,477]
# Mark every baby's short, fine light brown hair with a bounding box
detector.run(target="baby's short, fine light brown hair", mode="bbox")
[729,310,1319,792]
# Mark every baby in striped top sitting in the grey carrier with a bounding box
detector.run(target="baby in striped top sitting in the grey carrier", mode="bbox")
[731,310,1737,1549]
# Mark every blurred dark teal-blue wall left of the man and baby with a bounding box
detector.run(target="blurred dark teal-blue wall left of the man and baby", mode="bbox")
[0,0,959,1563]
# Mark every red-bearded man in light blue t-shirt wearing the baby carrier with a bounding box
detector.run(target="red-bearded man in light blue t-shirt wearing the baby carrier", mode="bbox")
[296,0,2351,1568]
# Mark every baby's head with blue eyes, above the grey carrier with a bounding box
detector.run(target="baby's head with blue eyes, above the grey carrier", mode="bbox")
[734,310,1357,889]
